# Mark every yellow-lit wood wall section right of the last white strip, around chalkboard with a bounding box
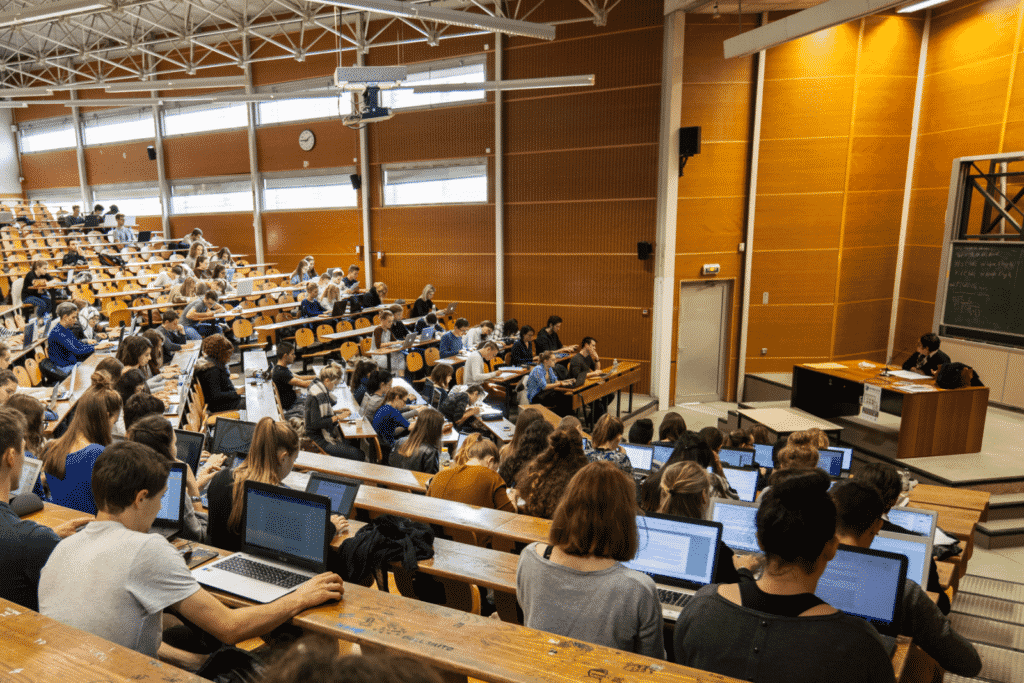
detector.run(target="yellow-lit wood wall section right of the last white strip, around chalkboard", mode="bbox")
[894,0,1024,360]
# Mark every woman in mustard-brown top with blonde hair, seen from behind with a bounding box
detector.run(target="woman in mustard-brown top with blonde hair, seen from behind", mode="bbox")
[427,434,515,512]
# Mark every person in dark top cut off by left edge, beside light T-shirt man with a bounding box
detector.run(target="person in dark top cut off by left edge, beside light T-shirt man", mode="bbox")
[0,407,92,610]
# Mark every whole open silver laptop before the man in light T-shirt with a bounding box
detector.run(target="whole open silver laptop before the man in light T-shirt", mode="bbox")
[193,481,331,603]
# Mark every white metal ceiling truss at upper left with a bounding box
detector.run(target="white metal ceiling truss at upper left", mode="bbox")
[0,0,606,88]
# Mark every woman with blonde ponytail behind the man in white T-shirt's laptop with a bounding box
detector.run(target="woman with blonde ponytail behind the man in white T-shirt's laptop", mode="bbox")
[207,418,348,551]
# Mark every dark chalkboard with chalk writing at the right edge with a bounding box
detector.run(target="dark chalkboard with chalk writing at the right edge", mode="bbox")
[942,242,1024,345]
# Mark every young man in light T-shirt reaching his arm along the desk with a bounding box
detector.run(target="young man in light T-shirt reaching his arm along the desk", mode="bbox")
[39,441,343,671]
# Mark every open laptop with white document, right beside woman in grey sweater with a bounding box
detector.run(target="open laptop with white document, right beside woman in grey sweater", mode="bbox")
[625,513,722,622]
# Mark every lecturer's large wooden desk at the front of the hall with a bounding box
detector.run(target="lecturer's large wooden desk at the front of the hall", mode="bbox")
[790,360,988,459]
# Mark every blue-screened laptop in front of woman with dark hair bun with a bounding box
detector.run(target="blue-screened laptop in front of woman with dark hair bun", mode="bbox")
[814,546,907,637]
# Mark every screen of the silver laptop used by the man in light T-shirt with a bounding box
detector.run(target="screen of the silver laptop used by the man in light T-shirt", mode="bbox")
[242,482,330,565]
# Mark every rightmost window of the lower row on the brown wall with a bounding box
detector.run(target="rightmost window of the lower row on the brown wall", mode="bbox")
[384,159,487,206]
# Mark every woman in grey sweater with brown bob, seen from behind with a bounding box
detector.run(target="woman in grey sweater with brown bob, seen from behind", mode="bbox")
[516,463,663,669]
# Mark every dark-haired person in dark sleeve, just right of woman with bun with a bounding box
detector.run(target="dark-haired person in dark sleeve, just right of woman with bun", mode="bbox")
[830,479,981,678]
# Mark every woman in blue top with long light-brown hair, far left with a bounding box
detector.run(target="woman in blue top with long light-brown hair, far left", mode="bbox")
[41,373,121,515]
